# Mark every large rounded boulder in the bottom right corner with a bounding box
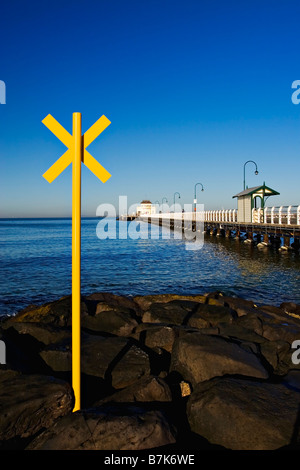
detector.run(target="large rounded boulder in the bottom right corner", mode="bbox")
[187,377,300,450]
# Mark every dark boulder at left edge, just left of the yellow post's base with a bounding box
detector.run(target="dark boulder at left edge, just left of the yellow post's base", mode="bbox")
[0,370,74,441]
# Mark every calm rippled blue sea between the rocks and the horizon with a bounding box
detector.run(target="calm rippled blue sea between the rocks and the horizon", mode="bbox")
[0,218,300,315]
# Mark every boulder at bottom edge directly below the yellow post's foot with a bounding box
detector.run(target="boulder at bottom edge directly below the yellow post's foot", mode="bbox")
[27,405,176,451]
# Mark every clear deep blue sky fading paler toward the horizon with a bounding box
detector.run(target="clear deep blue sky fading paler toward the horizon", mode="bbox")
[0,0,300,217]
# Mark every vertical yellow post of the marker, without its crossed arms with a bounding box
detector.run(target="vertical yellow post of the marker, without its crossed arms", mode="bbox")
[72,113,82,411]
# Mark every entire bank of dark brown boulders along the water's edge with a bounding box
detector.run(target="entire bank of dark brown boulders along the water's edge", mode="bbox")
[0,293,300,451]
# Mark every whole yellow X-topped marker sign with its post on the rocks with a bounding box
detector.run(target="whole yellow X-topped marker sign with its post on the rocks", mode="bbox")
[42,113,111,411]
